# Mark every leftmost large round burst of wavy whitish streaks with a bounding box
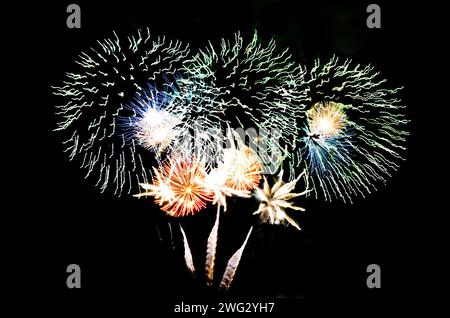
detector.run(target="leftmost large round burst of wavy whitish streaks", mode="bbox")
[53,29,189,196]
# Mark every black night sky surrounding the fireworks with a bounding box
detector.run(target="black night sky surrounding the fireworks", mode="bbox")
[3,0,439,316]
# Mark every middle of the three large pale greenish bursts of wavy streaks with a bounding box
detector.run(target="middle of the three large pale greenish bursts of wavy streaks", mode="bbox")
[183,32,305,173]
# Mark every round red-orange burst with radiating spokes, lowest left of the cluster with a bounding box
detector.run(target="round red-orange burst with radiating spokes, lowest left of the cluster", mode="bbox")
[135,158,213,217]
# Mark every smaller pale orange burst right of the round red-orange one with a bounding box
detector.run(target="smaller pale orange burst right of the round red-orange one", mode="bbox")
[224,145,262,191]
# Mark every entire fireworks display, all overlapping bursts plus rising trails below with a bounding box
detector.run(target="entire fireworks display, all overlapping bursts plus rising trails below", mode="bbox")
[52,29,408,289]
